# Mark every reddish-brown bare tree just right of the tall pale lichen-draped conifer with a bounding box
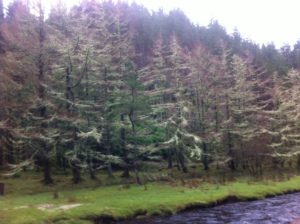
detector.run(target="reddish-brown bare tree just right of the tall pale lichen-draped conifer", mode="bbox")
[189,47,222,170]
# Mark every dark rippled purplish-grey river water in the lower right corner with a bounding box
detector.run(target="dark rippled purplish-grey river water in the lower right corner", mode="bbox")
[122,193,300,224]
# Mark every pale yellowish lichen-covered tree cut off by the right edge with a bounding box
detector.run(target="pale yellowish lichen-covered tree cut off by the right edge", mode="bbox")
[269,70,300,167]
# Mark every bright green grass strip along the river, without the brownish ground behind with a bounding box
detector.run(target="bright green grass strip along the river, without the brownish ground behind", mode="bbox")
[0,177,300,224]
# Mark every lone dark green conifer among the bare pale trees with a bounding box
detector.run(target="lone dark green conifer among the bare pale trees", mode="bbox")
[113,60,151,184]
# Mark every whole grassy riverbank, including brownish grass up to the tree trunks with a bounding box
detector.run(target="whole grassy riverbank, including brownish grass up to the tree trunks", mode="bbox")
[0,169,300,224]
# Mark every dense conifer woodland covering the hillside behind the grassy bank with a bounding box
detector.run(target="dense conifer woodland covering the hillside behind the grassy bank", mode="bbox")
[0,0,300,184]
